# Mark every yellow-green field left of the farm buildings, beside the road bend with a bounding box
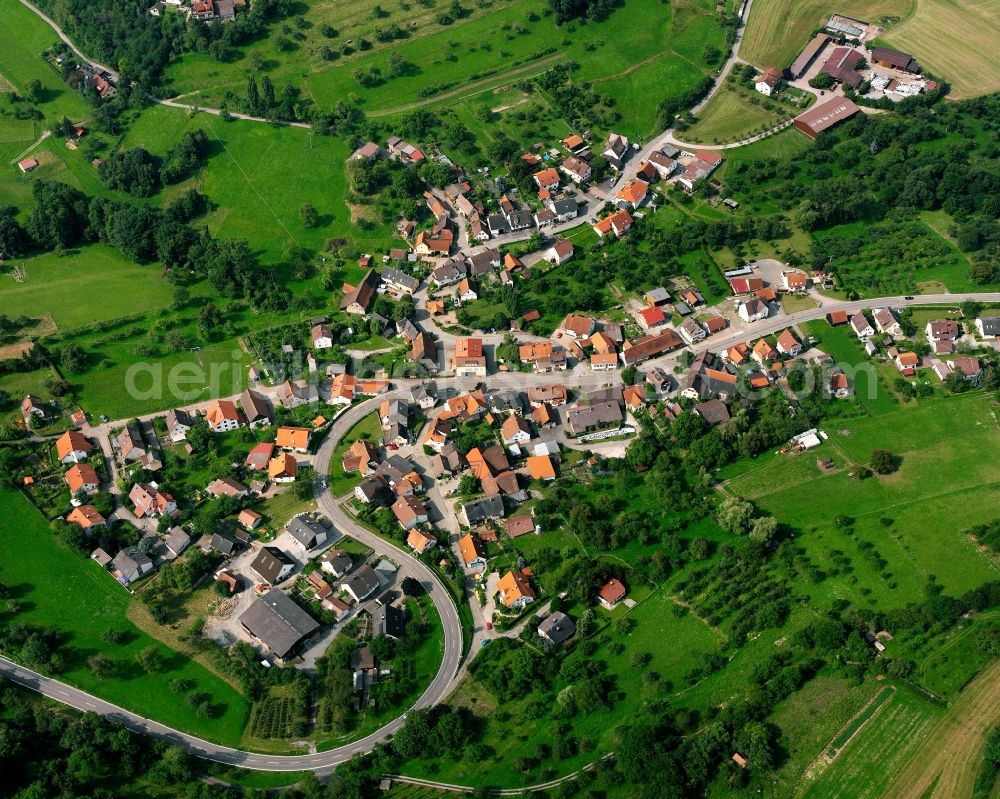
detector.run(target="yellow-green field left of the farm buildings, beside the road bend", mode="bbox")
[740,0,913,69]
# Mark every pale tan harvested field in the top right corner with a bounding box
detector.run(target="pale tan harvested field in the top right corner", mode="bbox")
[884,0,1000,97]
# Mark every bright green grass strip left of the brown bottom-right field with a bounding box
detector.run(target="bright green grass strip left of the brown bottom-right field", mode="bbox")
[799,689,942,799]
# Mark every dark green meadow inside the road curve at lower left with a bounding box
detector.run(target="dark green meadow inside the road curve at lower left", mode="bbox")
[0,491,248,745]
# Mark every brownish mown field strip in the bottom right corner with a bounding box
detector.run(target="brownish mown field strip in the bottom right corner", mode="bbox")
[885,662,1000,799]
